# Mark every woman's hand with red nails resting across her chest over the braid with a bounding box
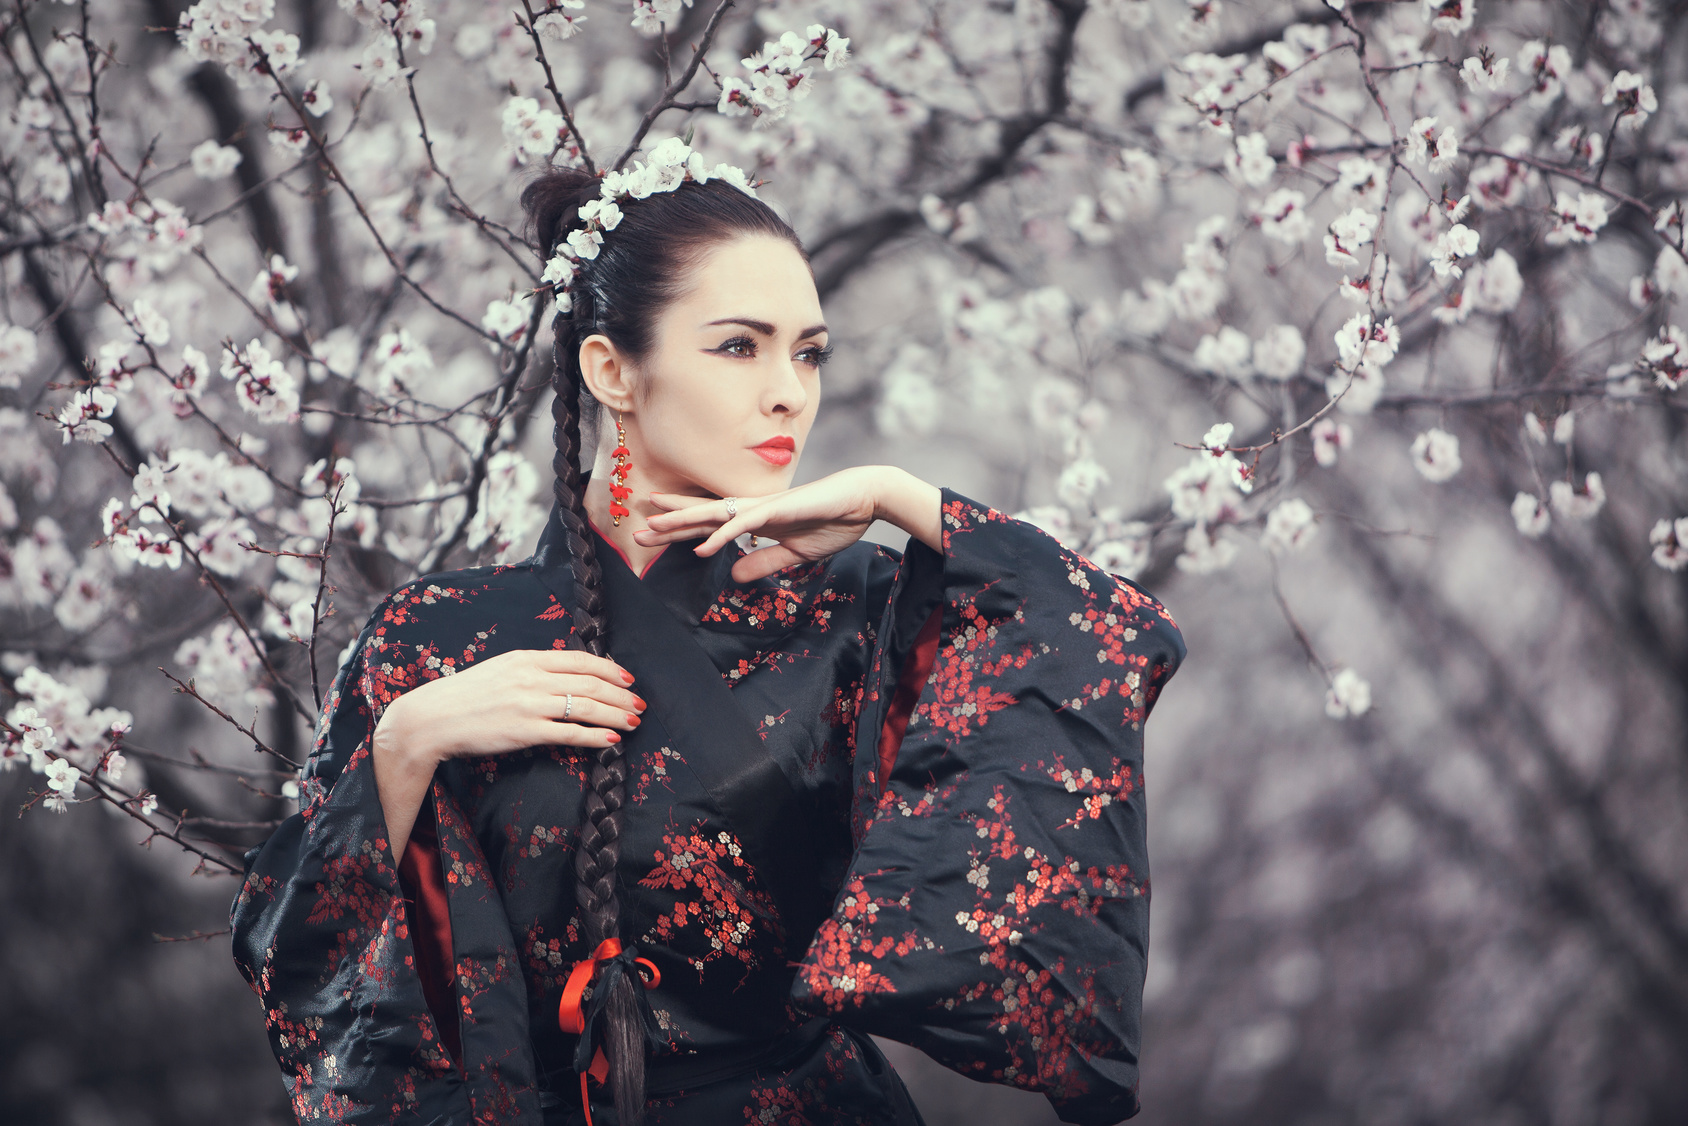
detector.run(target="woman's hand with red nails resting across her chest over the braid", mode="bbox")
[375,648,645,763]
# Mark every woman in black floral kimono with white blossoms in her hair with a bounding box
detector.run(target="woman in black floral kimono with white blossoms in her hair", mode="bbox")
[233,142,1183,1126]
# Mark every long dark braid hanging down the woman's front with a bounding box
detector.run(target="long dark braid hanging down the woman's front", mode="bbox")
[550,295,645,1126]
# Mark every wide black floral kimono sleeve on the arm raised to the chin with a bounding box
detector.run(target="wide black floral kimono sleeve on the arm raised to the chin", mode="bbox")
[793,490,1185,1123]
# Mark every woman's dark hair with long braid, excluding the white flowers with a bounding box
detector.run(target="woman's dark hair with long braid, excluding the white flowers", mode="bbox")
[522,160,809,1126]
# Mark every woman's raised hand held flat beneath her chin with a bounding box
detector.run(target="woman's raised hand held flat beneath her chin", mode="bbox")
[633,466,944,582]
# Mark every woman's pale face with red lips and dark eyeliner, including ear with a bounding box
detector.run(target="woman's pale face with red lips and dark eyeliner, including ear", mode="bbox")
[581,235,827,512]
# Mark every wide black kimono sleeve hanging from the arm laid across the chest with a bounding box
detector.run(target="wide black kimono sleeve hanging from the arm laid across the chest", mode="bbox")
[231,587,540,1126]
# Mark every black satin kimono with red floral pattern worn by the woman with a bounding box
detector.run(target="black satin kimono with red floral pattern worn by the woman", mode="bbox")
[233,490,1185,1126]
